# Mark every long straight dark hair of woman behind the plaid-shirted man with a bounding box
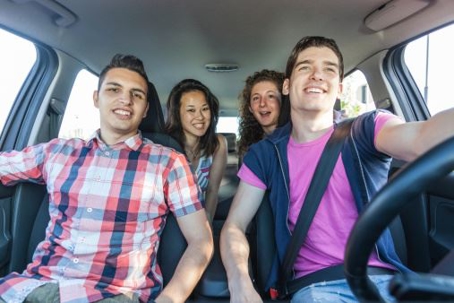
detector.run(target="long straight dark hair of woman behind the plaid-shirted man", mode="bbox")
[165,79,219,159]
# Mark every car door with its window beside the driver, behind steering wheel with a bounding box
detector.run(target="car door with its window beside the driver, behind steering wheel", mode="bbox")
[384,25,454,275]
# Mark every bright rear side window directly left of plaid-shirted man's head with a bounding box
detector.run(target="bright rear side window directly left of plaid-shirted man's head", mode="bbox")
[58,70,100,139]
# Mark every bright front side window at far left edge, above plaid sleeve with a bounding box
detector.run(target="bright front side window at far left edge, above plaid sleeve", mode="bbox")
[0,29,36,133]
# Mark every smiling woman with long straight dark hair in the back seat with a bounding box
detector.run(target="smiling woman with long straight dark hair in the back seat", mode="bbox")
[165,79,227,222]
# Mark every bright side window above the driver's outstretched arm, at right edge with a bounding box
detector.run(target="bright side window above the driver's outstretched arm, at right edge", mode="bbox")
[404,25,454,115]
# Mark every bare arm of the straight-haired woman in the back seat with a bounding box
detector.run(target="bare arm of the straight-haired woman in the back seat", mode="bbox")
[205,135,227,222]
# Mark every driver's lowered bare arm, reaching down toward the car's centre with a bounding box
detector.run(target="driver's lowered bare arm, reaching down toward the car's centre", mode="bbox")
[220,181,265,303]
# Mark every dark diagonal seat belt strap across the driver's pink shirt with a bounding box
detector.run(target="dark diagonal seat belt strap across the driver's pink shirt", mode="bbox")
[272,118,354,297]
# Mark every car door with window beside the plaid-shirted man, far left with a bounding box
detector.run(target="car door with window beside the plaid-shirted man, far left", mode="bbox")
[0,29,58,276]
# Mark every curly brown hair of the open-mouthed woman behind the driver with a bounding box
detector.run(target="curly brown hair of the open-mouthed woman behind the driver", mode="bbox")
[238,69,290,158]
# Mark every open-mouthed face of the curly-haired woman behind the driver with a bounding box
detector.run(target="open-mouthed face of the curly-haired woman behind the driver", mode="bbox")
[249,81,281,134]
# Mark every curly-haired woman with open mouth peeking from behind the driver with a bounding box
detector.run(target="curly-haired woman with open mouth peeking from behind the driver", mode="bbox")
[238,69,290,163]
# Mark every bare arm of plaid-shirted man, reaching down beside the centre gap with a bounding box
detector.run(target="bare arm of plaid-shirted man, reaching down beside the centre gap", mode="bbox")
[156,210,213,303]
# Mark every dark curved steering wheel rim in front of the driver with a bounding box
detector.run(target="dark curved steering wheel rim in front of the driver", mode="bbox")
[344,137,454,302]
